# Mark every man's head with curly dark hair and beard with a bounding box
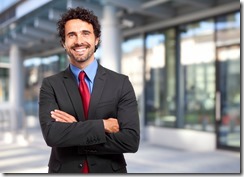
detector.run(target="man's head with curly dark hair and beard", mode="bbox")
[57,7,101,68]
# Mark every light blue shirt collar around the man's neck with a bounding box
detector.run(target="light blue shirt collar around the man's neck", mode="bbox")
[70,59,98,83]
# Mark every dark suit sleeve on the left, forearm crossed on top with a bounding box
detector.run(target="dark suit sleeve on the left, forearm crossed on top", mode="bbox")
[39,78,107,147]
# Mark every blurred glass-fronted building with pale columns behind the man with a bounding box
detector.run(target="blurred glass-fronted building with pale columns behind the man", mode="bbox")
[0,0,241,158]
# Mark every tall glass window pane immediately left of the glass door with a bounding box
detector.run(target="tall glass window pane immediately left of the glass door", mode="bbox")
[180,19,215,131]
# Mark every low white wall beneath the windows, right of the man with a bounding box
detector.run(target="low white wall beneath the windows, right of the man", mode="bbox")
[146,126,216,151]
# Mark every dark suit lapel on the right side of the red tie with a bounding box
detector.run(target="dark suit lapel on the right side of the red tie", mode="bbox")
[88,64,106,120]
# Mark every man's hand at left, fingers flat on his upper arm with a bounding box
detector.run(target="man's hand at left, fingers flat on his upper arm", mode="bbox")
[51,109,77,123]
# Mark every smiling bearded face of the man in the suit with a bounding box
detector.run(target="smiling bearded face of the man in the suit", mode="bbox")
[64,19,98,66]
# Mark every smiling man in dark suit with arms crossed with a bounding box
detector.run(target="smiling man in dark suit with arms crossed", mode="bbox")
[39,7,140,173]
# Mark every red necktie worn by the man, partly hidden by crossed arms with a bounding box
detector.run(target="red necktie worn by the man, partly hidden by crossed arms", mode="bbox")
[79,71,90,173]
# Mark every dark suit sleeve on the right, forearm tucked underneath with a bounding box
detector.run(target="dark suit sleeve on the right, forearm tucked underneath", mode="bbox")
[83,77,140,154]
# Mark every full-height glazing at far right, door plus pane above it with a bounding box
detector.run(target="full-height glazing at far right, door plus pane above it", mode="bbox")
[216,12,241,147]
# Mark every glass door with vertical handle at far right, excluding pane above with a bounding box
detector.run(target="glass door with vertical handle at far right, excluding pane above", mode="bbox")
[216,45,241,150]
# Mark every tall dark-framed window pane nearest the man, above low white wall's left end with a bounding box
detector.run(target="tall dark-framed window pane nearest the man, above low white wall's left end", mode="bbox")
[145,30,176,127]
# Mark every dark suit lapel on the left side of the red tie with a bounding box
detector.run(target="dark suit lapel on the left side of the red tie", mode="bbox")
[64,67,85,121]
